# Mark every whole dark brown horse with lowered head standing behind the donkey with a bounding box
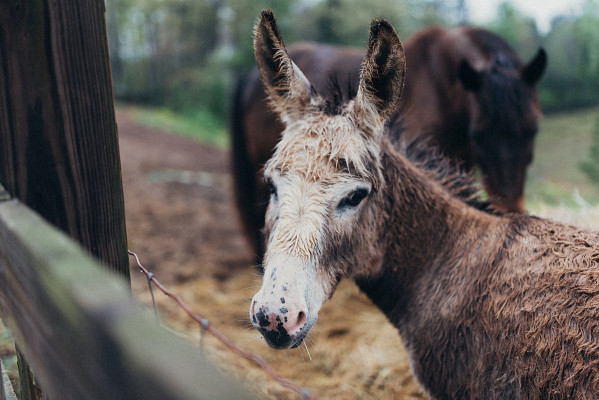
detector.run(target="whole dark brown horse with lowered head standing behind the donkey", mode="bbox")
[231,24,546,262]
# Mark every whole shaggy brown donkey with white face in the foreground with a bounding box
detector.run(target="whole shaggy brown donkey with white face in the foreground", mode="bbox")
[250,11,599,399]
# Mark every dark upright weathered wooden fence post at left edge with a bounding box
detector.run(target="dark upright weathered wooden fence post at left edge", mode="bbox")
[0,0,129,398]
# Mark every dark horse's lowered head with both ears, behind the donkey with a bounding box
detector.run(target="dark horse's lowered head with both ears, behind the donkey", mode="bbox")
[458,49,547,211]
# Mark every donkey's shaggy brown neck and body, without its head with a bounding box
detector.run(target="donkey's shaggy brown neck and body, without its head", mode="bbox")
[357,144,599,399]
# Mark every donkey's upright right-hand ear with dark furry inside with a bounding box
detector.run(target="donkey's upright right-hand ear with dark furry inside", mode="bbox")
[356,19,406,136]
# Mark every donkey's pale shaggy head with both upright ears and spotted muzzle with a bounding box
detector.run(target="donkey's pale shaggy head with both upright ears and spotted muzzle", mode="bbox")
[250,11,405,349]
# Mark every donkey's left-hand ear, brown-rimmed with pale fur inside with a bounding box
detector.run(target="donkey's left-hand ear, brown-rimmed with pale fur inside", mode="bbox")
[254,10,312,122]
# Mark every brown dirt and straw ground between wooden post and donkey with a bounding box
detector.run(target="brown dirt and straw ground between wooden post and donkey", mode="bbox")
[117,110,422,399]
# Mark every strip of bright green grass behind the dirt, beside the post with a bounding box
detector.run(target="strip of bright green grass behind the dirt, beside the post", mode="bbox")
[126,105,229,149]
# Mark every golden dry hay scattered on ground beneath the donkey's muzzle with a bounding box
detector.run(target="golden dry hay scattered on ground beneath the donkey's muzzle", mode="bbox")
[134,269,422,399]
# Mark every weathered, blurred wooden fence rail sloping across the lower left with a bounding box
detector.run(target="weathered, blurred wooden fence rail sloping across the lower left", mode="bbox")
[0,186,252,400]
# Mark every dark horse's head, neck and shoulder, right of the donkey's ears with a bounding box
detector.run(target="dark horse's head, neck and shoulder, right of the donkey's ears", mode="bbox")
[399,28,547,212]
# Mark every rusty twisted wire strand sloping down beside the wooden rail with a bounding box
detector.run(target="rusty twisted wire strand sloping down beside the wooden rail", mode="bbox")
[127,250,318,400]
